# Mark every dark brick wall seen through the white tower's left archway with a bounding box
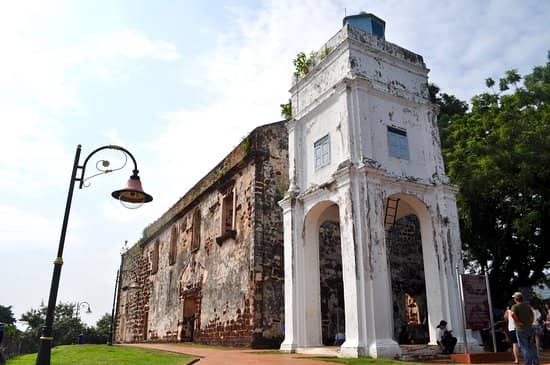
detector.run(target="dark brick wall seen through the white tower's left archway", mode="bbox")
[319,221,346,346]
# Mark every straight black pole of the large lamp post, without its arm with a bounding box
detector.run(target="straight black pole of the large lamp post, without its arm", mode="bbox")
[36,145,82,365]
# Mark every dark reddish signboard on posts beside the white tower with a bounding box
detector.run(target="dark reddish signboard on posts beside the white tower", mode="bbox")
[460,274,491,330]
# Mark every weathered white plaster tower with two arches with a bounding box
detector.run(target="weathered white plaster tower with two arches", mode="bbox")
[280,18,470,357]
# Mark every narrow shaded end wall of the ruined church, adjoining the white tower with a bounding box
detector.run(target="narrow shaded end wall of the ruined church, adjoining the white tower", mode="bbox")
[252,124,288,348]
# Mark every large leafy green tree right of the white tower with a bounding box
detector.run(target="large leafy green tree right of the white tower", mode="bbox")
[432,53,550,306]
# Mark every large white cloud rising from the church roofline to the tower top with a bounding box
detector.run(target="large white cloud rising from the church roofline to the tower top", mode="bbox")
[143,1,350,213]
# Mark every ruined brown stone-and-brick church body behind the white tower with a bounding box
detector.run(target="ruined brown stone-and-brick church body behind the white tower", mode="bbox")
[115,122,288,348]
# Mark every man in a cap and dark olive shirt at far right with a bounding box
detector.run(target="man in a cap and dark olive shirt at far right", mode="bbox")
[512,292,539,365]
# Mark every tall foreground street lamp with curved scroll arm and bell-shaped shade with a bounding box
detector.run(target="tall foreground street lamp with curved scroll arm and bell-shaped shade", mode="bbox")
[36,145,153,365]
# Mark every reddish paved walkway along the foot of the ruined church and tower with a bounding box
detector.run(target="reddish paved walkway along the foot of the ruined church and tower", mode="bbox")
[122,343,550,365]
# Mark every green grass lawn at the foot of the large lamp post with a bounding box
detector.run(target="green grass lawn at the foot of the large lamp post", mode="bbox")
[7,345,195,365]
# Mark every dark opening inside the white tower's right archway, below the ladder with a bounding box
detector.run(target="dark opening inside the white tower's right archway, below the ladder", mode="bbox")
[386,200,430,344]
